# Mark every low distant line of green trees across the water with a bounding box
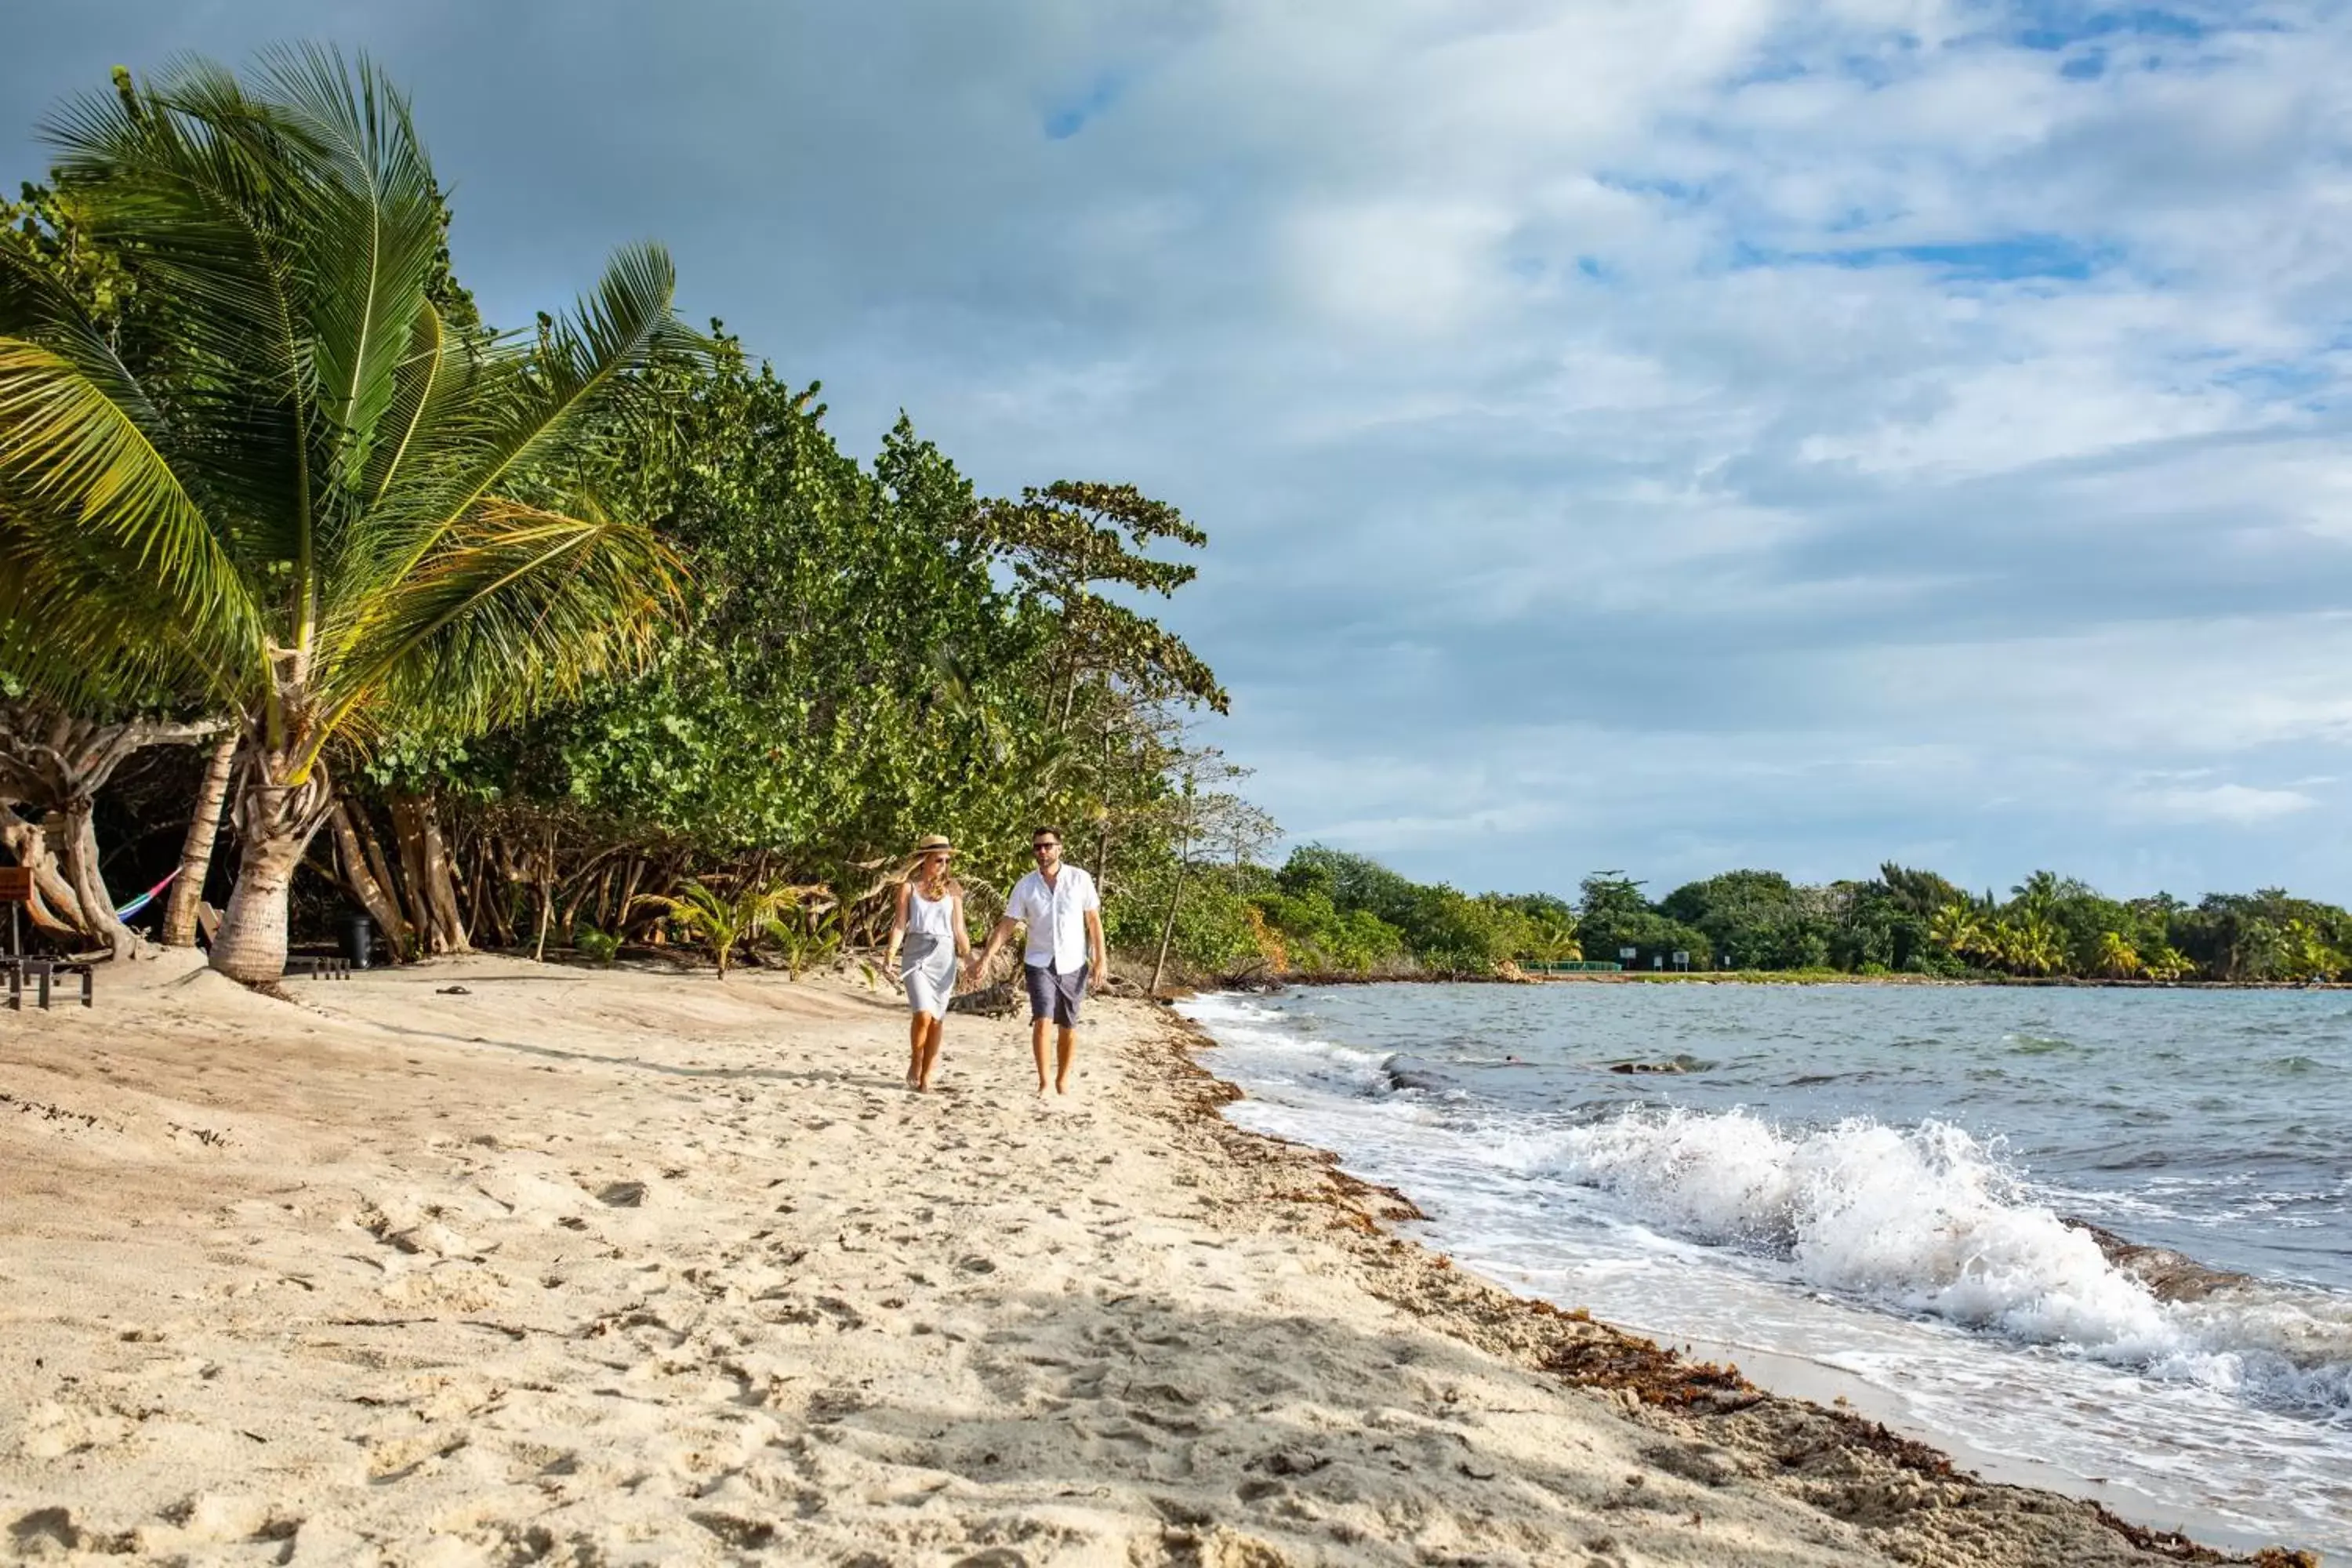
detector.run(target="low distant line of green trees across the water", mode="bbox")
[1129,844,2352,980]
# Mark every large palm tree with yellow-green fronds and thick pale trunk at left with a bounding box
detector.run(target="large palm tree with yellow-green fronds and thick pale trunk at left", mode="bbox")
[0,49,701,982]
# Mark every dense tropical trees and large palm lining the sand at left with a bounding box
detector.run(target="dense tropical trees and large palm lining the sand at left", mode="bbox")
[0,49,1232,980]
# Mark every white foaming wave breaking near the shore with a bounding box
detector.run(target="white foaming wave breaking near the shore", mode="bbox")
[1517,1109,2352,1420]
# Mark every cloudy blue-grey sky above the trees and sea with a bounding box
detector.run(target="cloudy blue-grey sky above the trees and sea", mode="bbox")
[13,0,2352,900]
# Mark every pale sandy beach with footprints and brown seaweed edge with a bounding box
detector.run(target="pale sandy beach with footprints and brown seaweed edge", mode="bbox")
[0,956,2314,1568]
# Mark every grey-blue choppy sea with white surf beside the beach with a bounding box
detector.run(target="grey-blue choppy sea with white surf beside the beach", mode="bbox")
[1185,982,2352,1556]
